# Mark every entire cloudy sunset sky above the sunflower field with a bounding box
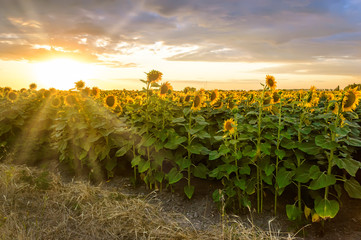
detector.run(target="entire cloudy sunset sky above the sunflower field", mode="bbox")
[0,0,361,90]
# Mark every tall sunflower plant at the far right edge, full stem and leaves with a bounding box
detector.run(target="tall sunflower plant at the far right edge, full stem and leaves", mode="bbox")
[309,88,361,223]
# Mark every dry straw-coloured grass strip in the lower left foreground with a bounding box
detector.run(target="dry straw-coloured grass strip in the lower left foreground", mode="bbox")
[0,164,292,239]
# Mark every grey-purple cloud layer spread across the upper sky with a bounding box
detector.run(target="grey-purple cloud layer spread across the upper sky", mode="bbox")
[0,0,361,71]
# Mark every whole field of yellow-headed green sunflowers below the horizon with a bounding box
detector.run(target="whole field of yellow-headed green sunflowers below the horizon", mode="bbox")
[0,70,361,222]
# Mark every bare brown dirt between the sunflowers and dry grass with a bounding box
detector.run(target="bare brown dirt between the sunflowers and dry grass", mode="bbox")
[99,172,361,240]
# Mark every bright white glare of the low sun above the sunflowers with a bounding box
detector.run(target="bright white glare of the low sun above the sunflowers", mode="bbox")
[34,58,93,90]
